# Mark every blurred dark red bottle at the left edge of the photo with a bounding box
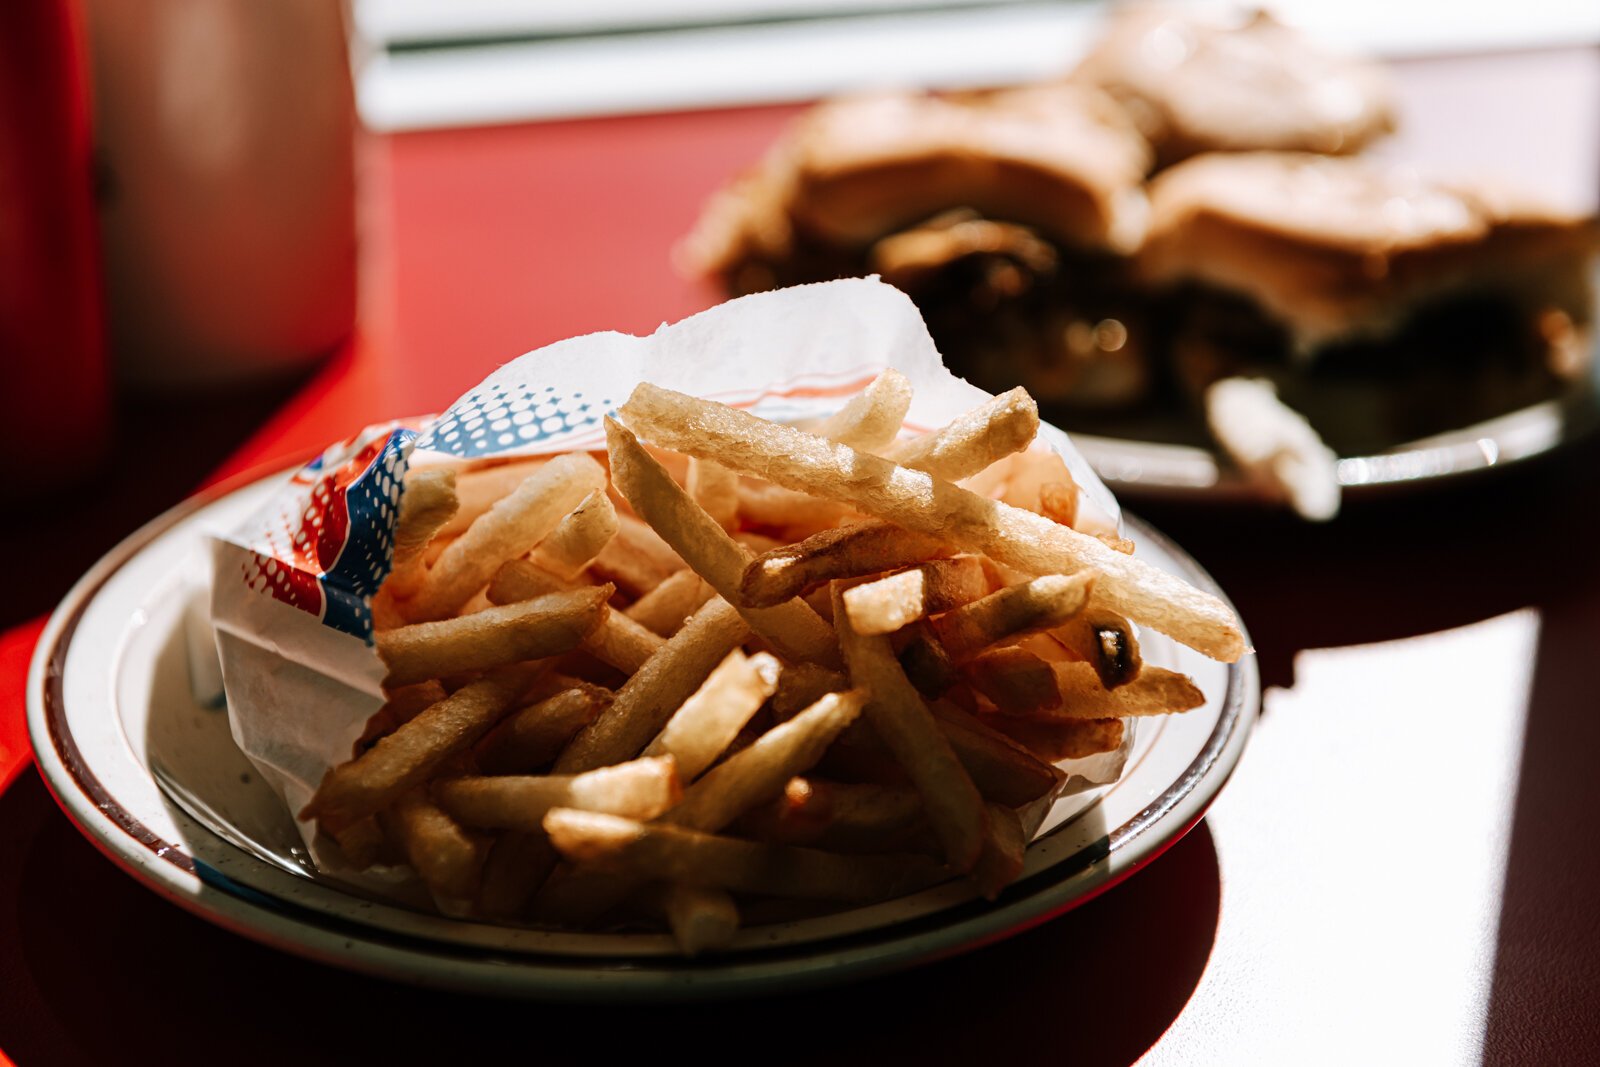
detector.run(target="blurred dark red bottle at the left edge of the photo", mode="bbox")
[0,0,110,493]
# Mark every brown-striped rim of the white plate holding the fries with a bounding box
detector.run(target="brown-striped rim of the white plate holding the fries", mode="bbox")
[18,464,1259,1001]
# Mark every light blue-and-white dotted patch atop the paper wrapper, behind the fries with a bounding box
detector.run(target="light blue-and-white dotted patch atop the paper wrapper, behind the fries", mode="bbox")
[416,386,611,459]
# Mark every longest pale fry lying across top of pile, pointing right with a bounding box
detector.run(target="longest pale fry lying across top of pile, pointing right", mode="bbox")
[622,384,1245,662]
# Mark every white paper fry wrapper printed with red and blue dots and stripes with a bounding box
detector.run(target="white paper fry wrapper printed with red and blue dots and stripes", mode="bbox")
[211,278,1133,869]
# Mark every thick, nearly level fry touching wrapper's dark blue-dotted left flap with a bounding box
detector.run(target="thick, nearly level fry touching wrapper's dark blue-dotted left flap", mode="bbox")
[376,585,611,686]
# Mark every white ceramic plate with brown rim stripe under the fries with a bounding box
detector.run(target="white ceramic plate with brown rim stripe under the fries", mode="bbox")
[18,478,1259,1000]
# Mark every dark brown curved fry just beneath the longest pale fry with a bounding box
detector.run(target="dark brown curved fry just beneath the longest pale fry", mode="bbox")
[739,522,950,608]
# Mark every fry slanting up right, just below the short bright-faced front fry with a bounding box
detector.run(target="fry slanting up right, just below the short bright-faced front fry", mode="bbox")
[662,689,866,830]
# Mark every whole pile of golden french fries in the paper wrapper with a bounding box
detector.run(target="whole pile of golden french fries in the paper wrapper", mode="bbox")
[301,371,1245,955]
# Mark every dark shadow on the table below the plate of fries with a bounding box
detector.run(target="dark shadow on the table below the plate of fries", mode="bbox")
[0,773,1221,1065]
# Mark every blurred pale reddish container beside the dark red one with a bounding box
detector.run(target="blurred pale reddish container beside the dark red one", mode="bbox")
[86,0,357,390]
